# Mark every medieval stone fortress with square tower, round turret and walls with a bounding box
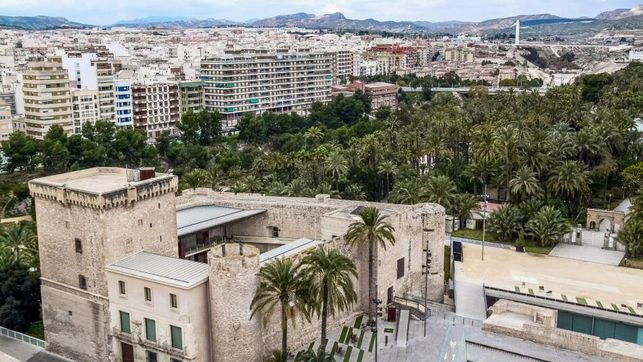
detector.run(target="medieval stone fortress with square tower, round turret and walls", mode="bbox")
[29,168,444,361]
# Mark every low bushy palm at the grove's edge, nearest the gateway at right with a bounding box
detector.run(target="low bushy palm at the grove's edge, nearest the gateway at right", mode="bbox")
[527,206,572,246]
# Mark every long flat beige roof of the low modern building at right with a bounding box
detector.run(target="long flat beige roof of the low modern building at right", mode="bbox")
[462,244,643,309]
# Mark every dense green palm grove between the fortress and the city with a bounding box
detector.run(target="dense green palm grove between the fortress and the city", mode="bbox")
[0,63,643,336]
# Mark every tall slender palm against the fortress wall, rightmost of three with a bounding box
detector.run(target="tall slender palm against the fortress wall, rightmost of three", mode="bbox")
[344,207,395,323]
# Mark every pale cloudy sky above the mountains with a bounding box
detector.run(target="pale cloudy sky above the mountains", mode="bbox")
[0,0,643,25]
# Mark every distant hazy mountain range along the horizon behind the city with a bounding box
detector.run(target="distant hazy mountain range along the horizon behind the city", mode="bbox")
[0,5,643,34]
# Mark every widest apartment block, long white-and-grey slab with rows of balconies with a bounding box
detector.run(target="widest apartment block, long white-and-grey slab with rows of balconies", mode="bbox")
[201,50,333,126]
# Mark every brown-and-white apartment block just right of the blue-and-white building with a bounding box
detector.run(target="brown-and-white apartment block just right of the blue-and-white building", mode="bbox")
[132,82,181,138]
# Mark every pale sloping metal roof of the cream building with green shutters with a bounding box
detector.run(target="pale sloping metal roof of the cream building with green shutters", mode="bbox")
[107,251,208,288]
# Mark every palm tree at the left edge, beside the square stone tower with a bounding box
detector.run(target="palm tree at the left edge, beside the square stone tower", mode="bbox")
[0,222,40,268]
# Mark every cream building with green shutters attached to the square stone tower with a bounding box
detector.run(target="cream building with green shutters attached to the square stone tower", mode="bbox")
[107,251,210,362]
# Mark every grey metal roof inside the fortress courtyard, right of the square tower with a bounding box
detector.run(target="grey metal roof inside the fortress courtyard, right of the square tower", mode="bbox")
[176,205,266,236]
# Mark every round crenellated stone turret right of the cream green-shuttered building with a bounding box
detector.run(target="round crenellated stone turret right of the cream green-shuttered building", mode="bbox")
[208,244,264,362]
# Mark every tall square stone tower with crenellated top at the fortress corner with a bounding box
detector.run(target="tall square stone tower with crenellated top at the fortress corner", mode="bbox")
[29,167,178,361]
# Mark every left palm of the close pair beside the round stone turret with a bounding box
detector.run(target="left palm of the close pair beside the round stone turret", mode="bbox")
[250,258,311,356]
